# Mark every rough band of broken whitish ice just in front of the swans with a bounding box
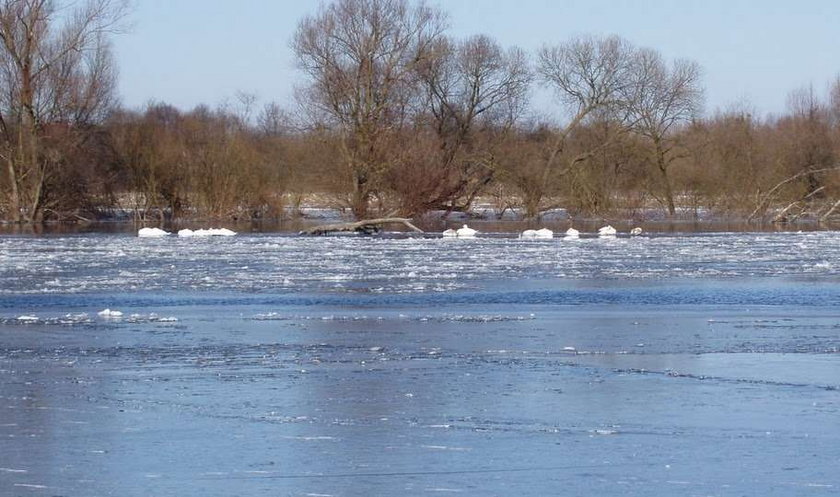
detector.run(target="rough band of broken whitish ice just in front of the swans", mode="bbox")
[0,232,840,294]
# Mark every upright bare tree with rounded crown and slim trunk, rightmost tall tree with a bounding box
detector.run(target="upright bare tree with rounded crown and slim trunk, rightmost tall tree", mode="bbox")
[625,49,703,216]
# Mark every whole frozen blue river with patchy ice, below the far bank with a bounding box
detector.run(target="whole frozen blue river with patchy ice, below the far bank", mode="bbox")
[0,232,840,497]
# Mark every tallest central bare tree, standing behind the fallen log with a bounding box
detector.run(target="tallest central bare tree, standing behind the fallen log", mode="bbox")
[292,0,446,218]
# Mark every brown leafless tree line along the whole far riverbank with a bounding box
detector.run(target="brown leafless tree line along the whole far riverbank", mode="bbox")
[0,0,840,224]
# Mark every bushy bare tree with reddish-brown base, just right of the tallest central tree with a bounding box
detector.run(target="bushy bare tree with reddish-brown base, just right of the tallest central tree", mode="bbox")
[390,35,530,215]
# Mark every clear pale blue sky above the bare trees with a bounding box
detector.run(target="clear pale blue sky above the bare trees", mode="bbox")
[115,0,840,115]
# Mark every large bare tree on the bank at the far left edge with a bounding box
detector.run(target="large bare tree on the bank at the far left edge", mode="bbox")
[0,0,126,222]
